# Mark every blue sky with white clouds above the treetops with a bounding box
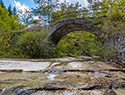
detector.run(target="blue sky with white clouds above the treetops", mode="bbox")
[3,0,87,10]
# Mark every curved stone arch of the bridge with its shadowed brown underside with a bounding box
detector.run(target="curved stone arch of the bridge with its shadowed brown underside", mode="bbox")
[49,18,100,45]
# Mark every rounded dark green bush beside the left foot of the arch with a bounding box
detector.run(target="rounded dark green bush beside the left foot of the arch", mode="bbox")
[18,31,55,58]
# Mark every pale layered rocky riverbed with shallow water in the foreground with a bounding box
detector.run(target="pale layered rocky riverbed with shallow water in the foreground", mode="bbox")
[0,56,125,95]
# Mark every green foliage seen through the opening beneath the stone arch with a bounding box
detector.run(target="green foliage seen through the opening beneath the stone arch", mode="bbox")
[57,31,102,56]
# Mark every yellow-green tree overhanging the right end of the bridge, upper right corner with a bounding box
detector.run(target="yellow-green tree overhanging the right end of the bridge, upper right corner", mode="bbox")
[88,0,125,34]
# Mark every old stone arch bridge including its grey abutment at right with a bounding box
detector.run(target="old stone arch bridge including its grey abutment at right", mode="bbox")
[23,18,125,63]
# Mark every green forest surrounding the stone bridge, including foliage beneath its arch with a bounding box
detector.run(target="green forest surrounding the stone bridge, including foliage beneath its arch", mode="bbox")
[0,0,125,60]
